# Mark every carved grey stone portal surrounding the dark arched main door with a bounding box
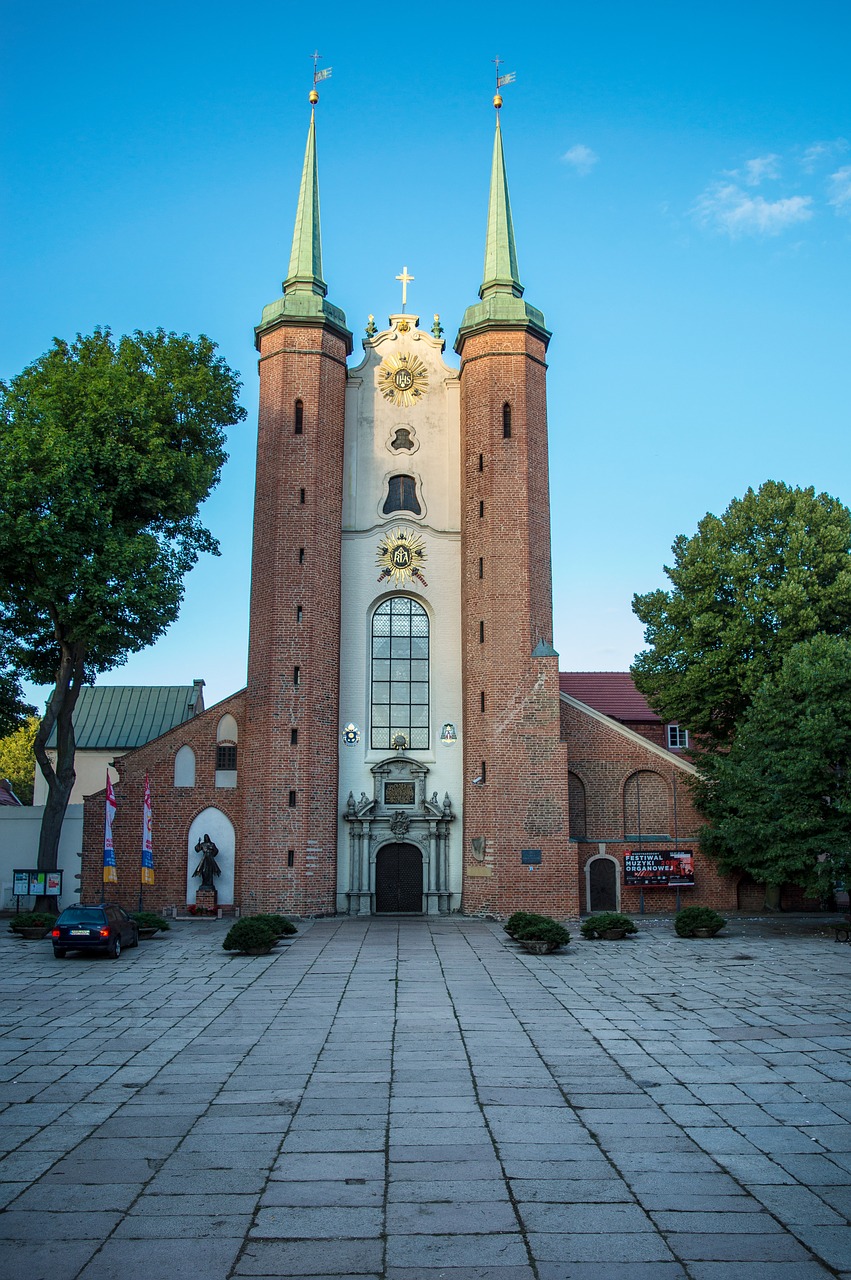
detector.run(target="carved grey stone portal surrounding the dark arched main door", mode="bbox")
[343,755,454,915]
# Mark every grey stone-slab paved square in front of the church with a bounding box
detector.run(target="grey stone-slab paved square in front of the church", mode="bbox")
[0,918,851,1280]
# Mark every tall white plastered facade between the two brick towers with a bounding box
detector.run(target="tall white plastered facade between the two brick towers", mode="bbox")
[337,315,463,914]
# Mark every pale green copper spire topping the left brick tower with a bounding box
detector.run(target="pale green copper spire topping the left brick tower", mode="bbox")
[255,96,352,352]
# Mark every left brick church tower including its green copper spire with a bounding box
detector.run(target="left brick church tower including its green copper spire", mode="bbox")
[238,90,352,915]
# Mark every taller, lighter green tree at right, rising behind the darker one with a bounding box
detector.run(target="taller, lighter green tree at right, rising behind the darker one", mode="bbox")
[632,480,851,751]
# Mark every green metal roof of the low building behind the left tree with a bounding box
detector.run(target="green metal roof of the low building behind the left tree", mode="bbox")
[47,680,203,751]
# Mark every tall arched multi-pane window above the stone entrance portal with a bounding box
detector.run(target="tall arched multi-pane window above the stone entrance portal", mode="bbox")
[370,595,429,751]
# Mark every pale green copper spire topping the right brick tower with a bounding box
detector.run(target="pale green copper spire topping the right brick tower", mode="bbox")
[456,104,550,352]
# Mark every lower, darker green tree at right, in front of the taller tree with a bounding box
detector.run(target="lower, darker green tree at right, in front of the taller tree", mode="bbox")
[700,635,851,899]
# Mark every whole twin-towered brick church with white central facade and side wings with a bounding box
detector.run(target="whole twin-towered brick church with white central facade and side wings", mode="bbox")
[82,91,735,918]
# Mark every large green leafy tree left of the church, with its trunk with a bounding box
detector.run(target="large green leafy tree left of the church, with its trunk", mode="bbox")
[0,329,244,896]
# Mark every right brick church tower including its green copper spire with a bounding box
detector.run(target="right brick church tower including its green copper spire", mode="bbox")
[456,96,578,915]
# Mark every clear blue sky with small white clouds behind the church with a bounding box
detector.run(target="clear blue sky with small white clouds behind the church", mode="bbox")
[0,0,851,704]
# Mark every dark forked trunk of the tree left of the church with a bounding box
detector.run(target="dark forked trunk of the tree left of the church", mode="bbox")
[33,644,84,911]
